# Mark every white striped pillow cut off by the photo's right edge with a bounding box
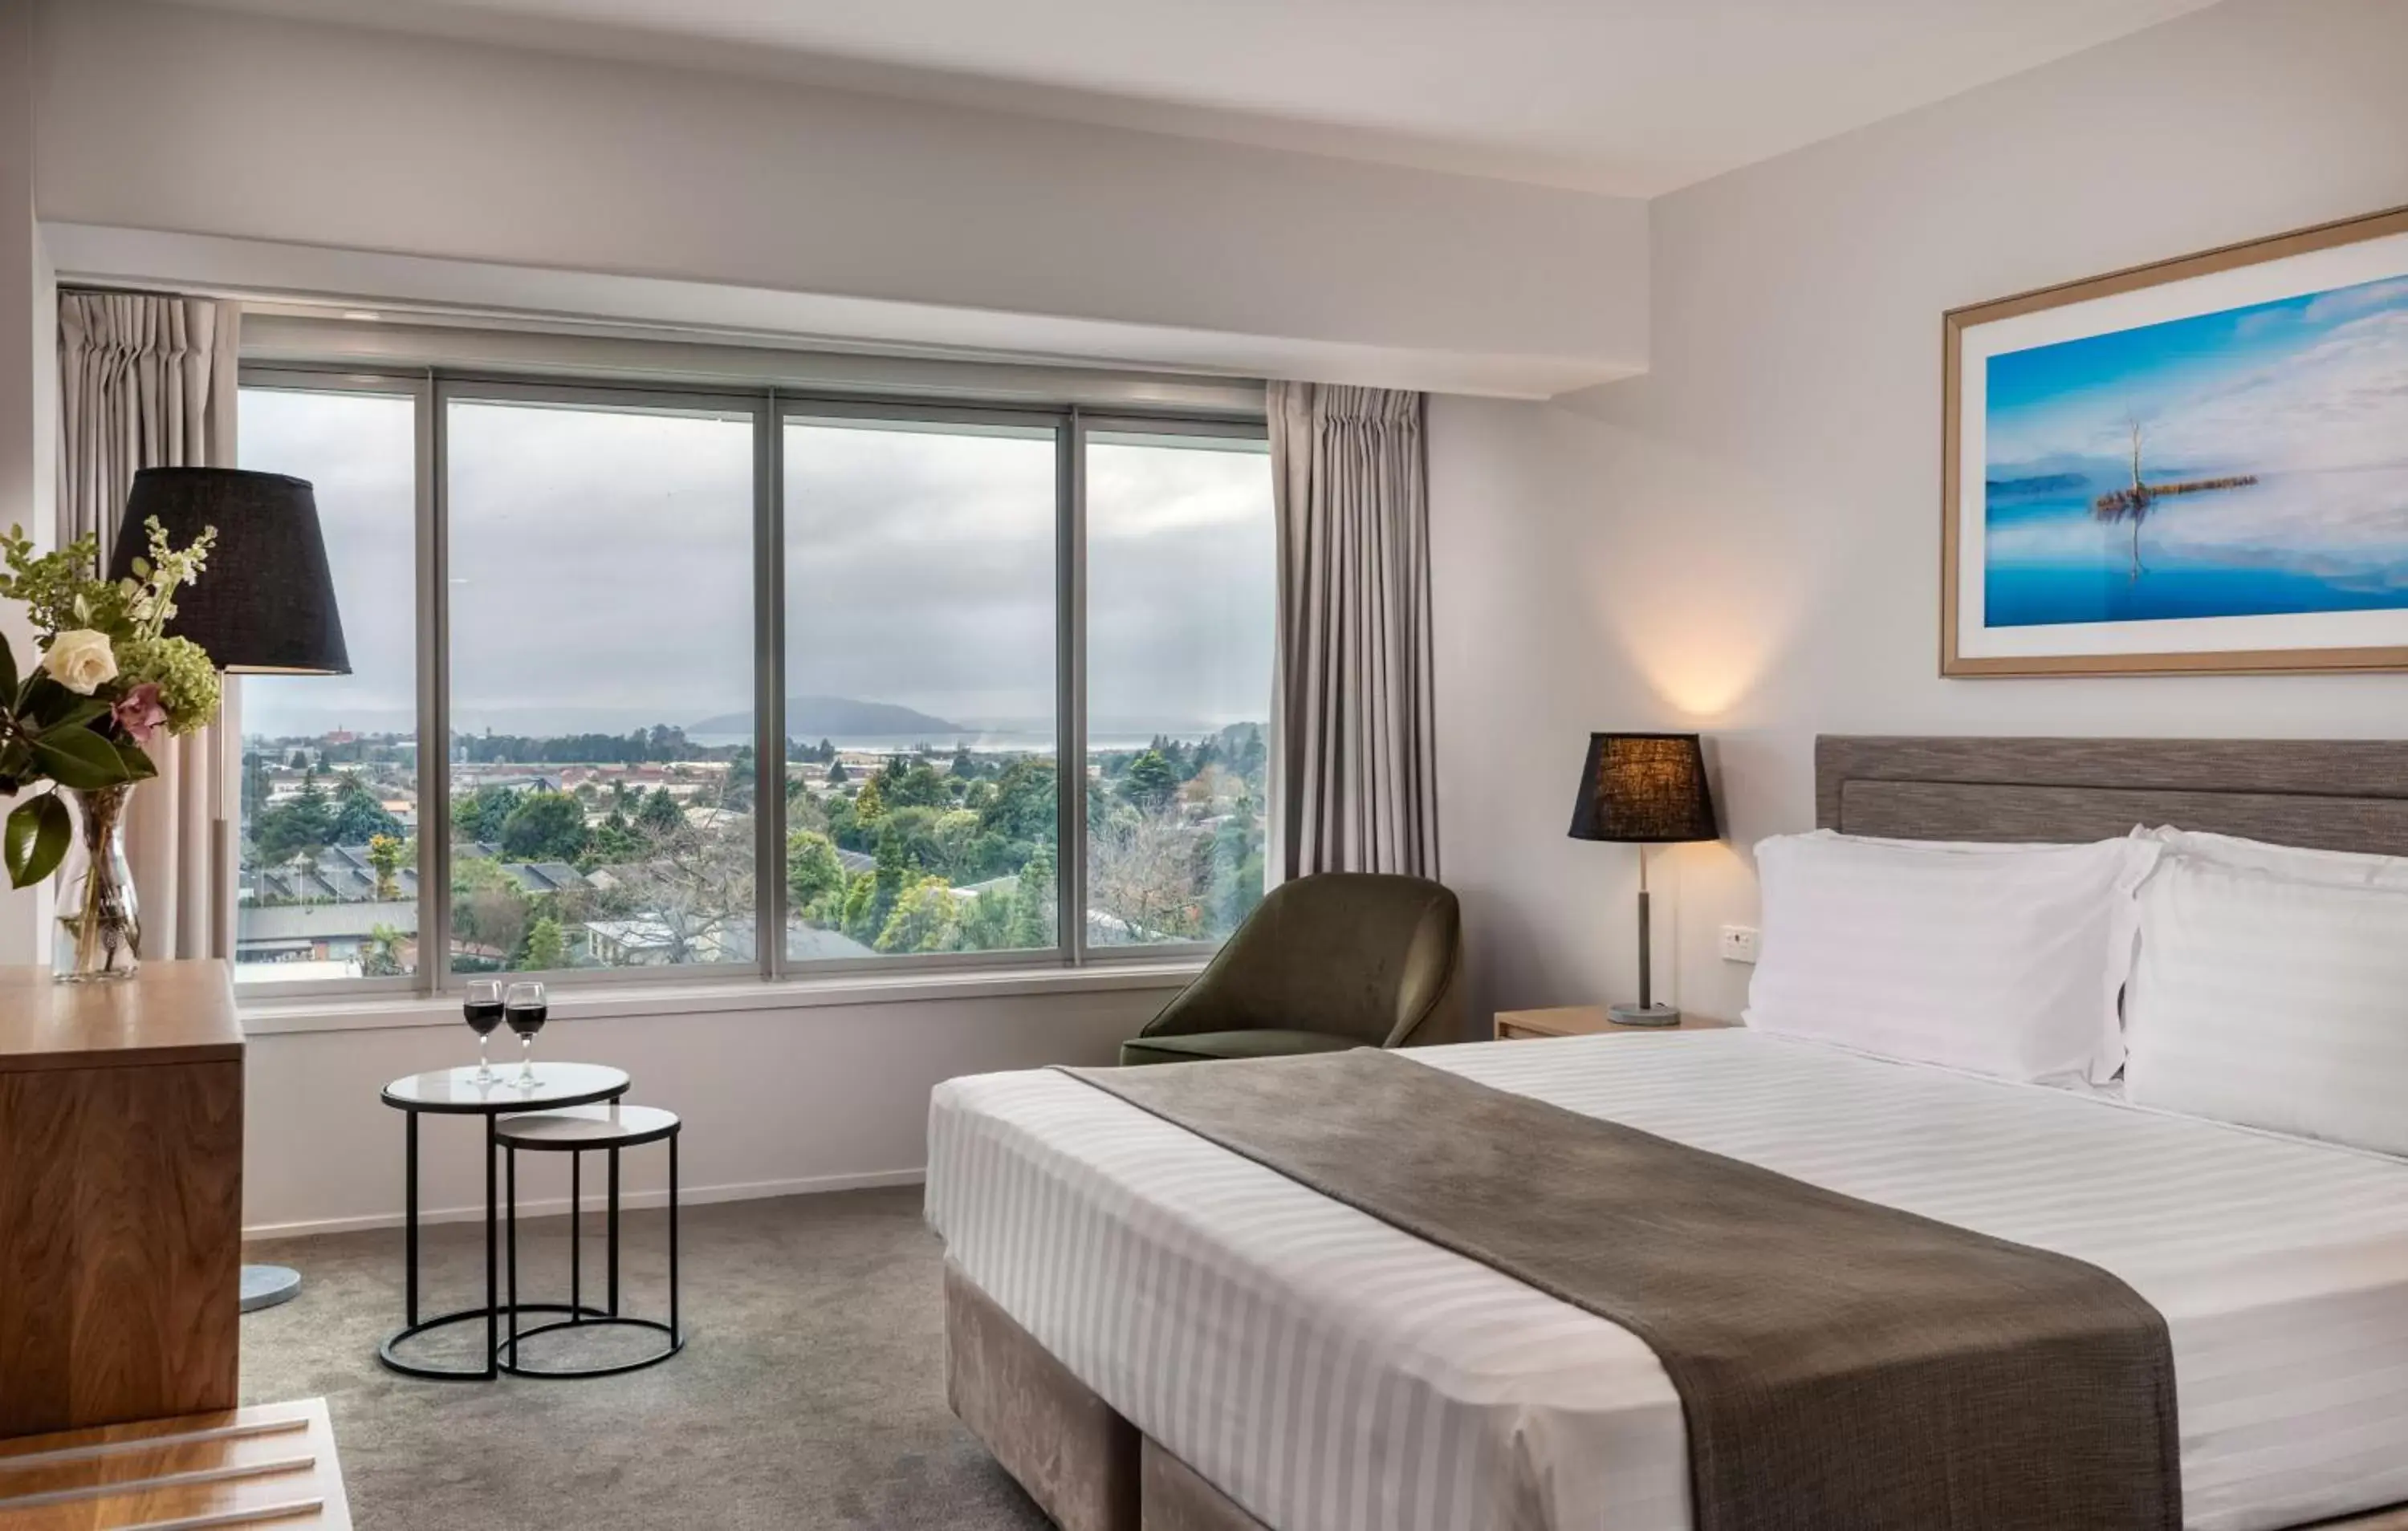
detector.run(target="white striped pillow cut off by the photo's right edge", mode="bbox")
[2124,857,2408,1153]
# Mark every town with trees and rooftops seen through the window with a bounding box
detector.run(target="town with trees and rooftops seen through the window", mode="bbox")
[236,722,1267,982]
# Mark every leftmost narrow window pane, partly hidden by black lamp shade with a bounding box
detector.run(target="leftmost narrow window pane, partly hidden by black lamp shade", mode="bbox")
[234,388,419,985]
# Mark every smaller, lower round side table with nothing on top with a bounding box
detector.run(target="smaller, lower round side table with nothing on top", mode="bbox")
[494,1105,686,1377]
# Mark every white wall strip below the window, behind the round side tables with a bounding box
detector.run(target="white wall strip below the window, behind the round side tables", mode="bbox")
[243,977,1175,1235]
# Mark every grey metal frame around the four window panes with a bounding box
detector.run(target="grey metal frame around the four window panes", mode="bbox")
[226,361,1279,1001]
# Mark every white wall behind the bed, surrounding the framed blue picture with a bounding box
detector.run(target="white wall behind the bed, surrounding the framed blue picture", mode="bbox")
[1430,0,2408,1035]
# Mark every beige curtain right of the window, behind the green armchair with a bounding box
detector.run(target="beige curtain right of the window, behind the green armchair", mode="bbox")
[1269,383,1438,879]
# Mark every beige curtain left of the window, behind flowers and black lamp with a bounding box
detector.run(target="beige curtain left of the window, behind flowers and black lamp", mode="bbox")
[58,291,238,958]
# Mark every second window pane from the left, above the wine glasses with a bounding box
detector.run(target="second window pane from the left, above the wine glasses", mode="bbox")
[443,392,756,973]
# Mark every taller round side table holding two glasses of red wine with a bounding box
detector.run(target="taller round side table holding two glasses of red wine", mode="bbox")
[376,1062,628,1382]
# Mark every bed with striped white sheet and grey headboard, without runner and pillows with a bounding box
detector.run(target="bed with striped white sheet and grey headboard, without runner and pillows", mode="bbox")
[929,739,2408,1531]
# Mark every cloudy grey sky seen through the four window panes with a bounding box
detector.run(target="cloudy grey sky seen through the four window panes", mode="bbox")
[241,390,1274,737]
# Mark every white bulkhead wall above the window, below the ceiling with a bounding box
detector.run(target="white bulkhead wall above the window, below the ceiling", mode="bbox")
[39,0,1647,400]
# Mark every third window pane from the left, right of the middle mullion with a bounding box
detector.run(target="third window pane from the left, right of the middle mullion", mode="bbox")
[785,416,1062,963]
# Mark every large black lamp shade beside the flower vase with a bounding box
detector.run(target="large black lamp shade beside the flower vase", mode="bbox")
[108,467,352,674]
